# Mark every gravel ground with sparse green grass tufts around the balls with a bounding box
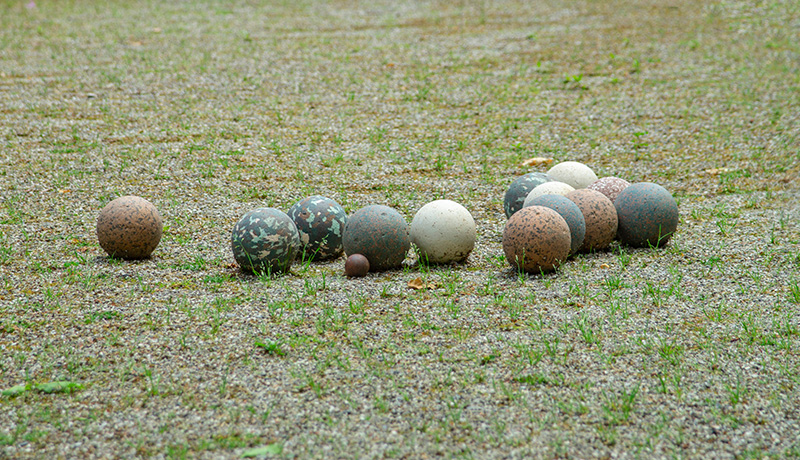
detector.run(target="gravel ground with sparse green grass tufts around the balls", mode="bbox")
[0,0,800,459]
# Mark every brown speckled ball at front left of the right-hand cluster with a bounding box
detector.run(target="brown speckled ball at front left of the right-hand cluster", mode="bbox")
[503,206,572,273]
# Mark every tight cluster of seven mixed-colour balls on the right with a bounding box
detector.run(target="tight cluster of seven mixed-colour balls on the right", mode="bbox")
[503,161,678,273]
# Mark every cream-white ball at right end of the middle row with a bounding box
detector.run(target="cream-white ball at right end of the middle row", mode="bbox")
[409,200,476,264]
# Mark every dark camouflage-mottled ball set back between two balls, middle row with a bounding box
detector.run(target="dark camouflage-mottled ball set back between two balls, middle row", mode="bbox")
[288,195,347,260]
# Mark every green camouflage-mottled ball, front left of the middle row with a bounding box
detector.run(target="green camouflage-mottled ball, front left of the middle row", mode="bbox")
[231,208,300,274]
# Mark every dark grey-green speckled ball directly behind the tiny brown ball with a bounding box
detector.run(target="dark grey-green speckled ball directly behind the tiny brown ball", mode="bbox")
[342,204,411,271]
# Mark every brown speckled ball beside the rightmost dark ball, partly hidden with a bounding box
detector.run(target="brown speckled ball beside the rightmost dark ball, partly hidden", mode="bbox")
[566,188,619,252]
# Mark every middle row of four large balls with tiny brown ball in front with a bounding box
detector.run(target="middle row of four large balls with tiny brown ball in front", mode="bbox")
[231,196,476,276]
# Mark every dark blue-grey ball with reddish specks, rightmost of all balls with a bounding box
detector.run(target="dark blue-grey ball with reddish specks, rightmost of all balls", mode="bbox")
[614,182,679,248]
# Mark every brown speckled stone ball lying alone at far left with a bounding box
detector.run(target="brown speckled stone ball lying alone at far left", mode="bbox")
[97,196,163,259]
